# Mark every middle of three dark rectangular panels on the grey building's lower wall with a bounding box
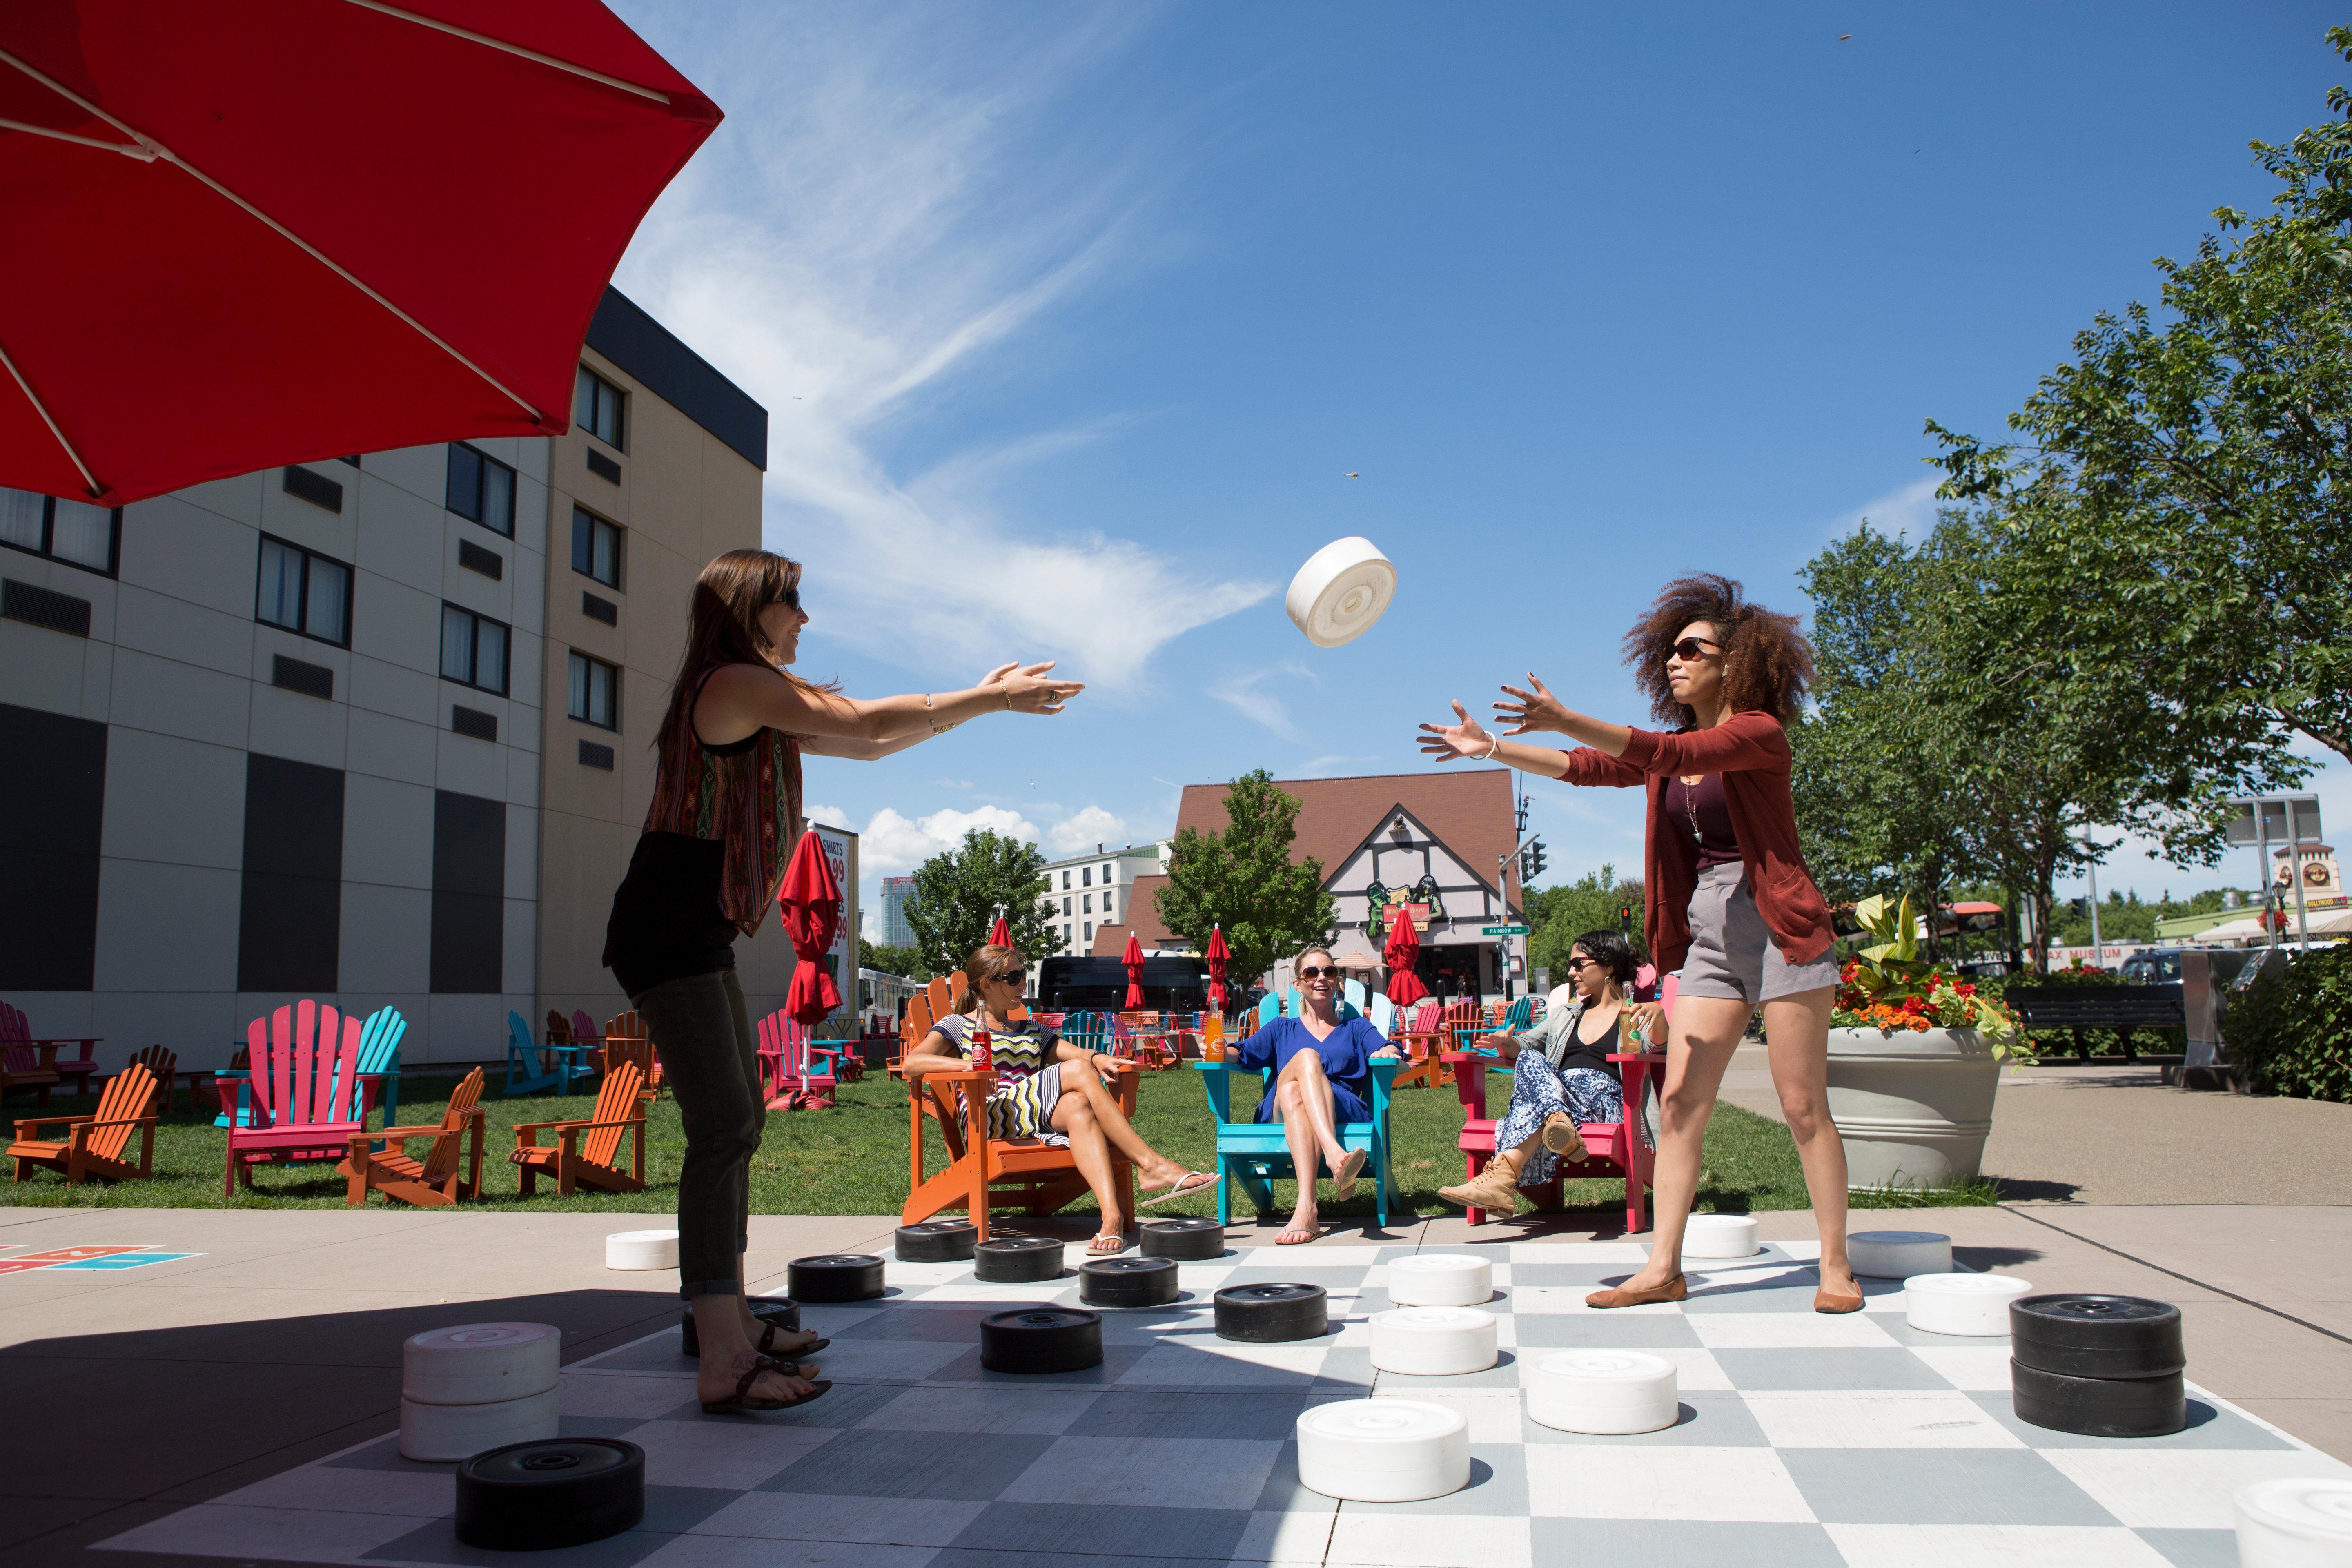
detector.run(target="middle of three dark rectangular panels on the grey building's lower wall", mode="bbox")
[238,752,343,994]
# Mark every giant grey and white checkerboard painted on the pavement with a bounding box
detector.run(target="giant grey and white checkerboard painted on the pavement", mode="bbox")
[106,1241,2352,1568]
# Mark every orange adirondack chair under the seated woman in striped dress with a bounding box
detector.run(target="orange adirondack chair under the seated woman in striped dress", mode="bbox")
[891,976,1136,1241]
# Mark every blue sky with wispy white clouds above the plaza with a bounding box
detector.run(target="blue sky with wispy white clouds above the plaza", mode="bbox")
[616,0,2352,931]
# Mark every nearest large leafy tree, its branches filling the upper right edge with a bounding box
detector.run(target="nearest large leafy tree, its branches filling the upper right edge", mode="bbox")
[1929,28,2352,771]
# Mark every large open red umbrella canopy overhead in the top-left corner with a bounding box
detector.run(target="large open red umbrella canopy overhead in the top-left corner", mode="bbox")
[0,0,720,506]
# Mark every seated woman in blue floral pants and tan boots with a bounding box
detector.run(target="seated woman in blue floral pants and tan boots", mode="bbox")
[1437,931,1665,1213]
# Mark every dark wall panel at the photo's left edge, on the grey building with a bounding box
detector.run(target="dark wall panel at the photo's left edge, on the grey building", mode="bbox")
[0,703,106,992]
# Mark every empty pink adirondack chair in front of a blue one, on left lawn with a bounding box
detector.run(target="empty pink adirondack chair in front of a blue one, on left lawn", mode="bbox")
[221,997,367,1196]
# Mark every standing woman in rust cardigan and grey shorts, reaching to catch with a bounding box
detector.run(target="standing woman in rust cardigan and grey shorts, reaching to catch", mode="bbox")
[1421,574,1863,1312]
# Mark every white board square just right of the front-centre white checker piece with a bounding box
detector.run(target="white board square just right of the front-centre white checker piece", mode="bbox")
[1526,1443,1813,1523]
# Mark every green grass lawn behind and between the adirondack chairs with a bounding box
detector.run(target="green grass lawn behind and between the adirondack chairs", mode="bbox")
[0,1069,1994,1218]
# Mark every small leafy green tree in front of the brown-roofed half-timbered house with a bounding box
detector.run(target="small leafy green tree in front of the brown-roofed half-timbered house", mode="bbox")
[1157,769,1338,987]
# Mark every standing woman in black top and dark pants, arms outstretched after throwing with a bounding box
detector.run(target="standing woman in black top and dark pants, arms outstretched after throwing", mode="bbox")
[604,550,1082,1413]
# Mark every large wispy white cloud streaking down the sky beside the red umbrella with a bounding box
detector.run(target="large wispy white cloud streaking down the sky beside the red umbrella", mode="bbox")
[621,7,1275,696]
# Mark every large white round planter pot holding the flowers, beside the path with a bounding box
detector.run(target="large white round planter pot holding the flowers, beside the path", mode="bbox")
[1830,1030,2002,1187]
